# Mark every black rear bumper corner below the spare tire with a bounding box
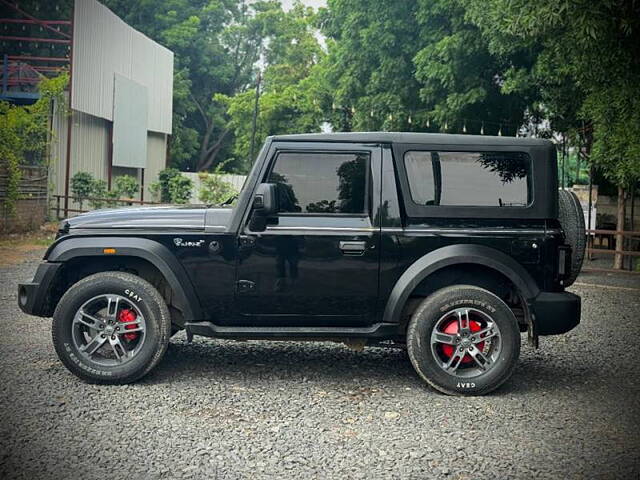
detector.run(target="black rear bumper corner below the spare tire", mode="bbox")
[529,292,581,335]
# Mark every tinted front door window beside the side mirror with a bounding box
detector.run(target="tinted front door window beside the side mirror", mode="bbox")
[268,153,369,213]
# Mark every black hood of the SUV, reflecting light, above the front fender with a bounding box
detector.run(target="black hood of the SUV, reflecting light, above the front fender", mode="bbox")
[60,205,207,232]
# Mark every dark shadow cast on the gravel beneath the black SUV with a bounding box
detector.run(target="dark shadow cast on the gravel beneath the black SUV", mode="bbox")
[143,340,595,396]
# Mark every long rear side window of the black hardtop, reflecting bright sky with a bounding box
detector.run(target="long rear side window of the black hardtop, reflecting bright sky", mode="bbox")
[404,151,531,207]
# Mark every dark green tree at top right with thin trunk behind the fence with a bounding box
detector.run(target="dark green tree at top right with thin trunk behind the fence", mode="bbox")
[463,0,640,268]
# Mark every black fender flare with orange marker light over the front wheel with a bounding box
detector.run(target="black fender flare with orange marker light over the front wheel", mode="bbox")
[45,237,203,322]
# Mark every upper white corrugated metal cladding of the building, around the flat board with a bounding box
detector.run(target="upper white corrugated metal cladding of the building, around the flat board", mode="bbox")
[72,0,173,133]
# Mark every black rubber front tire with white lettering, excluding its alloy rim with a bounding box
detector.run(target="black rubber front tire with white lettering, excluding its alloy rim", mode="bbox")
[52,272,171,385]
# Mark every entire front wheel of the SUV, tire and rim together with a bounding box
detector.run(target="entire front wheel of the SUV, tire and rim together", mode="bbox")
[52,272,171,384]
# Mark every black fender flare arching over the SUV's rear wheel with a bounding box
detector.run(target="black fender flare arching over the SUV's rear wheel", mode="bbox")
[383,245,540,323]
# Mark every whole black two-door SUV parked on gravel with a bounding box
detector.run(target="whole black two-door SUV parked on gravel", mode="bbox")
[19,133,585,395]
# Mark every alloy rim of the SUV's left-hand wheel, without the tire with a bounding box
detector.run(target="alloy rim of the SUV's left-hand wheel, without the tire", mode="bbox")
[71,294,146,366]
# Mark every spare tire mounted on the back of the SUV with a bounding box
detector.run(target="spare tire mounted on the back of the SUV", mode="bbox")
[558,190,587,287]
